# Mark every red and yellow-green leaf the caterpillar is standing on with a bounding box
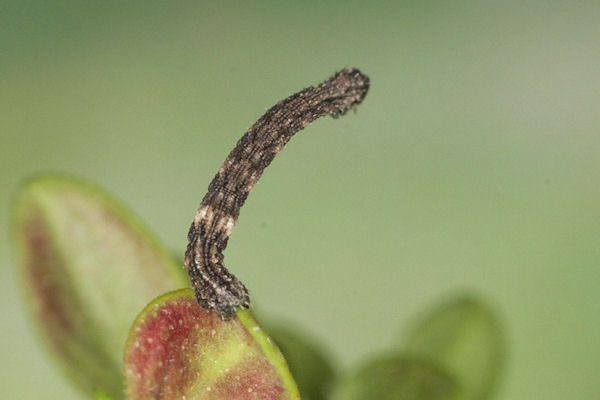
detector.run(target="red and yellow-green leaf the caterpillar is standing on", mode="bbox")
[124,289,300,400]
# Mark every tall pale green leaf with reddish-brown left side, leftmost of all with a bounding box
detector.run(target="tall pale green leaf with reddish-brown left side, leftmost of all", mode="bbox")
[14,176,188,399]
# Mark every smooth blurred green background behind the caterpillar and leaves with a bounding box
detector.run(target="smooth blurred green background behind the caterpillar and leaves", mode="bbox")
[0,1,600,399]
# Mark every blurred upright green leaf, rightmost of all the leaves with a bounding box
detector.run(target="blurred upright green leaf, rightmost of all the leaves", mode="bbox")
[404,296,504,400]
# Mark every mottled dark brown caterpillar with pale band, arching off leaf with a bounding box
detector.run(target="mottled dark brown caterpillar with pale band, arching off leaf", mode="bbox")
[185,69,369,320]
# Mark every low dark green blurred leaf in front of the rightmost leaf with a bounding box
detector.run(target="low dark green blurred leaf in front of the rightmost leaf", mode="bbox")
[331,355,462,400]
